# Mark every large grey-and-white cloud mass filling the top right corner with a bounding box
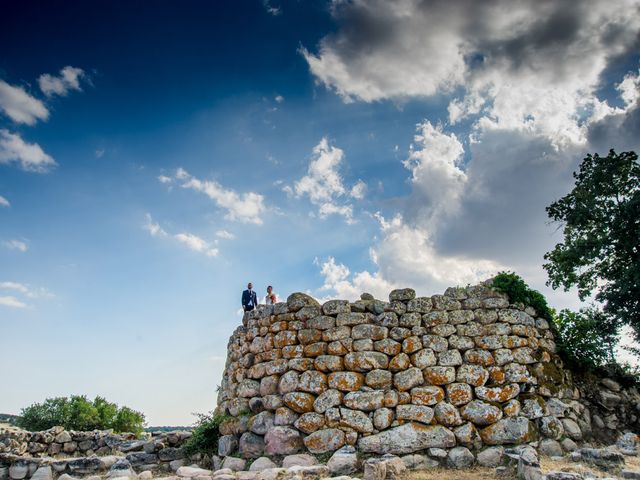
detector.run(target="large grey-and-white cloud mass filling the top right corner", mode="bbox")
[302,0,640,148]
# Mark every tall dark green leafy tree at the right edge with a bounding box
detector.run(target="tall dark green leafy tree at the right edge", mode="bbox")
[544,150,640,338]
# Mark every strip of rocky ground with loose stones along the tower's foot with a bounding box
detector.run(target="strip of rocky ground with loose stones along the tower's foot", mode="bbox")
[7,434,640,480]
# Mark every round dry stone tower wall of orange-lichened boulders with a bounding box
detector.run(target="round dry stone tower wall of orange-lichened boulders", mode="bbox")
[217,284,640,458]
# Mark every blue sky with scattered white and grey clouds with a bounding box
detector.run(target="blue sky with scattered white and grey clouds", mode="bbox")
[0,0,640,425]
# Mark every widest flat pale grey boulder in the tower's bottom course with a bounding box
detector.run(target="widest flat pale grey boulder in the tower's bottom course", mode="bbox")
[358,423,456,455]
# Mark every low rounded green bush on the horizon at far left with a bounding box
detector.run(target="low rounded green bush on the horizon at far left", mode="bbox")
[16,395,145,435]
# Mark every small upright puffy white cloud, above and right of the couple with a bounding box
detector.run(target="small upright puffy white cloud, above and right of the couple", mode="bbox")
[292,137,367,223]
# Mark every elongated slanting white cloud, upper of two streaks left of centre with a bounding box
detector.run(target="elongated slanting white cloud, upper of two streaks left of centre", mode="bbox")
[170,168,267,225]
